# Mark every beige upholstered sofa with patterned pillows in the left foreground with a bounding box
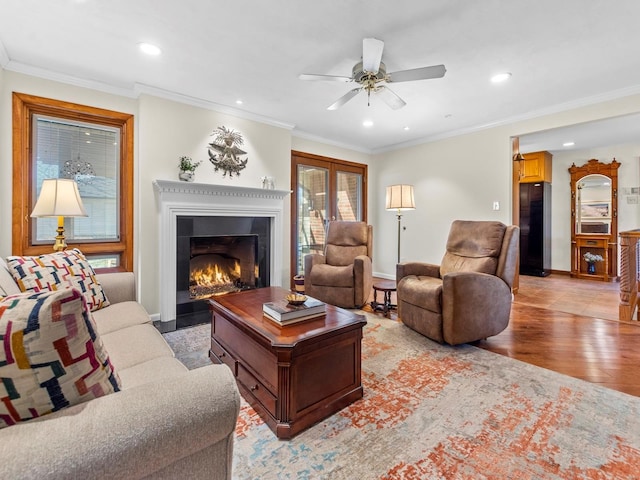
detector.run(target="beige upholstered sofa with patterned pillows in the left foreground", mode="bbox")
[0,260,240,479]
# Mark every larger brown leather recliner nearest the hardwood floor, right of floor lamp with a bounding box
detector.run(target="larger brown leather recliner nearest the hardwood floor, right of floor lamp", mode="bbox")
[396,220,520,345]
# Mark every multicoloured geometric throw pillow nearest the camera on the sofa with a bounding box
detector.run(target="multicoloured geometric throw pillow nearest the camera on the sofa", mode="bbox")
[0,288,120,428]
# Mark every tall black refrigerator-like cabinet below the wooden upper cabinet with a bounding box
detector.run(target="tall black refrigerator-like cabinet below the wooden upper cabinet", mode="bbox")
[520,182,551,277]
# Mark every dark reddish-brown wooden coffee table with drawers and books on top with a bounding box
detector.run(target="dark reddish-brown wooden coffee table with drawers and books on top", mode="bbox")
[209,287,367,439]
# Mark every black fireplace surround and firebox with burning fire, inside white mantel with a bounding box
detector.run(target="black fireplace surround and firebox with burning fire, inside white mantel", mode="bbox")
[176,216,271,328]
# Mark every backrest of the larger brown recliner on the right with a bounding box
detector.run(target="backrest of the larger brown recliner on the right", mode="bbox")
[440,220,507,277]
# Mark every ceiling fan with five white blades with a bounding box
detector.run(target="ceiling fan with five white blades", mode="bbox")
[299,38,447,110]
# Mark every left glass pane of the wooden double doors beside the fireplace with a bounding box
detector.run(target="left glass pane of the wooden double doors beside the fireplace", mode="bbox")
[293,165,329,274]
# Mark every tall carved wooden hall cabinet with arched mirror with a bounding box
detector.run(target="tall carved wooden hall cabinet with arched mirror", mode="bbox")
[569,158,620,282]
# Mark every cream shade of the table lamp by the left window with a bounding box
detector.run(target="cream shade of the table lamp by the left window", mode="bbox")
[31,178,88,217]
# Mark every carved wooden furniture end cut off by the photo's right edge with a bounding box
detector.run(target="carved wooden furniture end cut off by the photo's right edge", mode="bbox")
[619,229,640,320]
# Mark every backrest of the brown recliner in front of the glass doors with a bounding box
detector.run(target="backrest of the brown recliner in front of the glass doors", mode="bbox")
[325,220,372,266]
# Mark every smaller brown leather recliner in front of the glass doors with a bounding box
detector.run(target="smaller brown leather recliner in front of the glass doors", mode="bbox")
[304,221,373,308]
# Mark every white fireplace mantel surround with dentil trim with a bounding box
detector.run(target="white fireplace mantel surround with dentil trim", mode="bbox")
[153,180,291,330]
